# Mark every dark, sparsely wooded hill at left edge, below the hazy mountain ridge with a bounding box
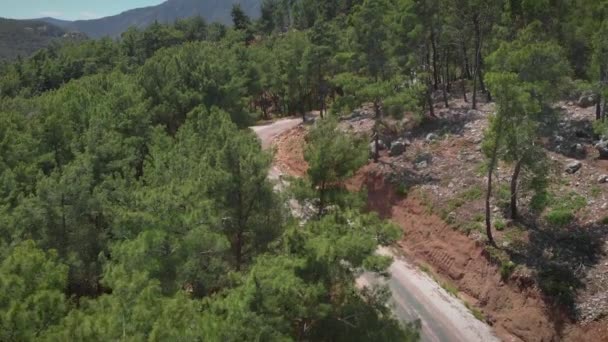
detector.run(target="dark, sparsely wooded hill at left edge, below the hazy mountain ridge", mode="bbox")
[0,18,66,60]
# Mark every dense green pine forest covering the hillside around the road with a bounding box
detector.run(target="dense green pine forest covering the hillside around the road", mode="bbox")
[0,0,608,341]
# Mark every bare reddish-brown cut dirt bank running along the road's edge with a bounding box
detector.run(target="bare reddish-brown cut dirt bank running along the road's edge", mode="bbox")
[275,123,608,341]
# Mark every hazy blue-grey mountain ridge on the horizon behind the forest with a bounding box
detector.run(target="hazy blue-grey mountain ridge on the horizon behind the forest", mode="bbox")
[40,0,262,38]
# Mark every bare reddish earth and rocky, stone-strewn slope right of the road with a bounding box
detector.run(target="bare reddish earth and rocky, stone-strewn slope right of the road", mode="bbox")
[270,92,608,341]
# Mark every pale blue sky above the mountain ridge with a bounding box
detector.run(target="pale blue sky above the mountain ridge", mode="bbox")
[0,0,164,20]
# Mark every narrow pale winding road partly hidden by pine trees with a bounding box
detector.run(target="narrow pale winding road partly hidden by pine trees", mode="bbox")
[251,119,499,342]
